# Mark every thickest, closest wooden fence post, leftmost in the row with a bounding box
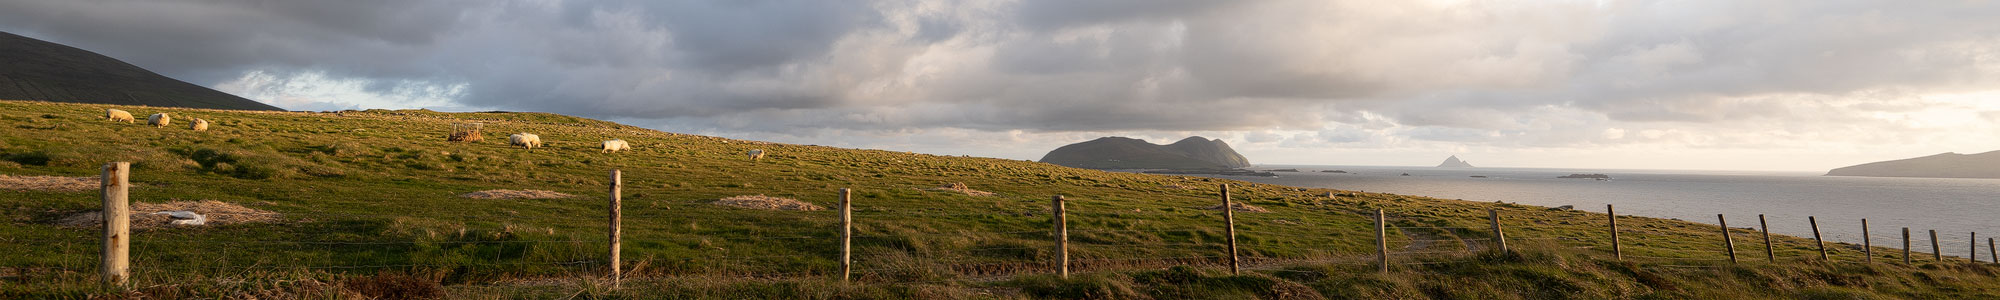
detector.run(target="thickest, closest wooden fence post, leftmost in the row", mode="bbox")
[100,162,132,286]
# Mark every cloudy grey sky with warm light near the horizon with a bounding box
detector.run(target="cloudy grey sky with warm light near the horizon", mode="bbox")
[0,0,2000,172]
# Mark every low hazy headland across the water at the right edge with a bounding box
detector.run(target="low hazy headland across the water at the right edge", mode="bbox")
[1826,152,2000,178]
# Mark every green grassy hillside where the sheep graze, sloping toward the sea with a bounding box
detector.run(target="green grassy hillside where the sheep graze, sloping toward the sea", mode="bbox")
[0,102,2000,298]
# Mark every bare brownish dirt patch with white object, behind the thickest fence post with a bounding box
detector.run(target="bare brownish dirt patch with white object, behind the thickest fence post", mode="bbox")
[56,200,280,230]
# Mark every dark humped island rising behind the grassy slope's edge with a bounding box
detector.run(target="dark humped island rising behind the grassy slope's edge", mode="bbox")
[1042,136,1250,170]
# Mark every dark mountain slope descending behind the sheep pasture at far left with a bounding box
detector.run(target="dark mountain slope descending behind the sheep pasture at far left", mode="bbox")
[0,32,280,110]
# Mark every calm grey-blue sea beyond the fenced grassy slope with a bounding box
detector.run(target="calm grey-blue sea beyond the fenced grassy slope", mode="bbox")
[1218,166,2000,260]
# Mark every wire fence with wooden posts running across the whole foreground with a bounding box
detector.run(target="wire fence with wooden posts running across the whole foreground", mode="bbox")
[0,165,2000,284]
